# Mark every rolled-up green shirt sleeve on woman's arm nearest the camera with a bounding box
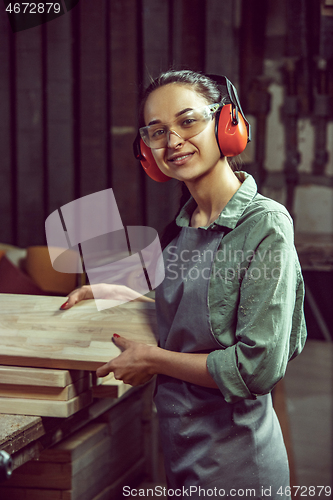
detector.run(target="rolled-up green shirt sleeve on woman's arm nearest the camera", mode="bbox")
[207,212,306,403]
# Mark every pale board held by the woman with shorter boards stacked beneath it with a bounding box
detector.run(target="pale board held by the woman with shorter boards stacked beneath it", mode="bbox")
[0,294,156,417]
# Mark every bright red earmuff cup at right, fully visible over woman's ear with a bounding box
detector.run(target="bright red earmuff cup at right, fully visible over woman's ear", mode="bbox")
[217,104,248,156]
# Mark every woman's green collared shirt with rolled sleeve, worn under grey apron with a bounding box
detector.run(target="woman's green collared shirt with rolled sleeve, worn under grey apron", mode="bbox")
[176,172,306,403]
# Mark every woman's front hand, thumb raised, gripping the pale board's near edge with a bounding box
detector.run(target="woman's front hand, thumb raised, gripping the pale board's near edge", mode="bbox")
[96,334,155,386]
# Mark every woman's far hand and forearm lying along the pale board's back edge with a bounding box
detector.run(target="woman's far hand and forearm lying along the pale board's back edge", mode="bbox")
[60,283,154,310]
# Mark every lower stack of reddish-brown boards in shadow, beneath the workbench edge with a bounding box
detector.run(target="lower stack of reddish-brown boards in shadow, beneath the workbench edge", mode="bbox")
[0,382,147,500]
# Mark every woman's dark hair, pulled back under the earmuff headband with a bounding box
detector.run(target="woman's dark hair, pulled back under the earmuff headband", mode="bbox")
[139,70,238,249]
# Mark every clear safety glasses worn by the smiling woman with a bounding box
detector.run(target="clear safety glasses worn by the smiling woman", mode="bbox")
[139,103,222,149]
